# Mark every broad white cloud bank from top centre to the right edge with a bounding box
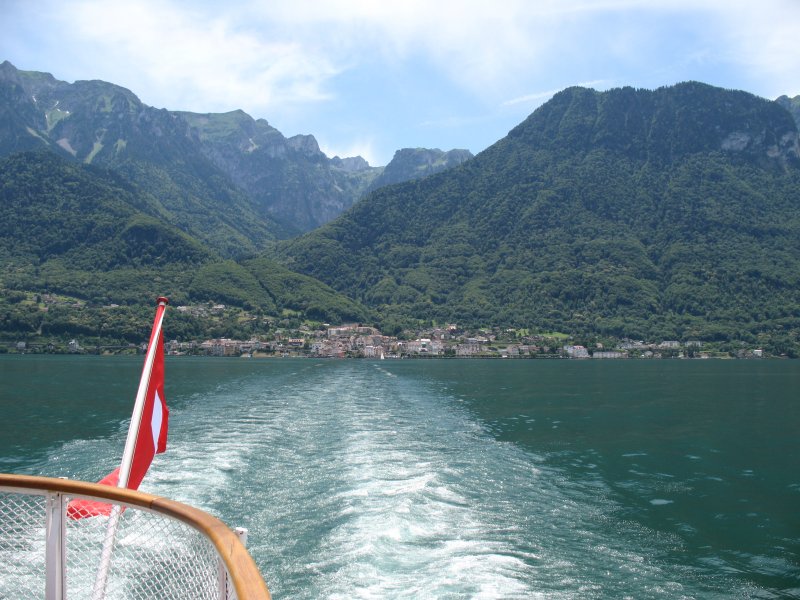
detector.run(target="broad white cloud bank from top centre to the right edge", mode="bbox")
[236,0,800,102]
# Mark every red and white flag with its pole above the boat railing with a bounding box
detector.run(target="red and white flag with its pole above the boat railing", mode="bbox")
[67,298,169,519]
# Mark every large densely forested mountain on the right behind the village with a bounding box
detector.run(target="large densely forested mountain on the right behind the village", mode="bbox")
[283,83,800,350]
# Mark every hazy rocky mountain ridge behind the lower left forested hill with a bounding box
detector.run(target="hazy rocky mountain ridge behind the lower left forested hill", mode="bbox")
[0,61,472,237]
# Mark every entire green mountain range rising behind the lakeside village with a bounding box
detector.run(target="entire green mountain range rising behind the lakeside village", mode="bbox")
[0,62,800,353]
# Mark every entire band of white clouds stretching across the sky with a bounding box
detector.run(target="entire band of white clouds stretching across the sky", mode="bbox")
[28,0,800,114]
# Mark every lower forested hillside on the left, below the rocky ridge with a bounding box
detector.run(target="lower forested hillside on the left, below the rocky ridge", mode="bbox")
[0,151,367,343]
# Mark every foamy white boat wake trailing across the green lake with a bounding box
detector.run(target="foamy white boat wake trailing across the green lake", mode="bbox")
[26,361,752,598]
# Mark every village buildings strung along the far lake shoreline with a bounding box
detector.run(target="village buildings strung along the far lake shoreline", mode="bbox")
[0,323,768,360]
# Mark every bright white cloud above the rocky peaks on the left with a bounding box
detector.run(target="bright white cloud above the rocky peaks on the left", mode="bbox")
[56,0,338,113]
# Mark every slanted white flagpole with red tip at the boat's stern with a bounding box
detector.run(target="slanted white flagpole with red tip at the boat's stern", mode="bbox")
[92,296,169,600]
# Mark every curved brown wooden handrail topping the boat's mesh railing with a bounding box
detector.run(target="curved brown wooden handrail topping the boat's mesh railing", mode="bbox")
[0,473,271,600]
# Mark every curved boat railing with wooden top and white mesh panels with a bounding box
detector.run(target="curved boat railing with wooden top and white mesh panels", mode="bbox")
[0,473,270,600]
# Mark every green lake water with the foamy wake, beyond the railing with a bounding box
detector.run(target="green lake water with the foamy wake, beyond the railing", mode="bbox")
[0,355,800,599]
